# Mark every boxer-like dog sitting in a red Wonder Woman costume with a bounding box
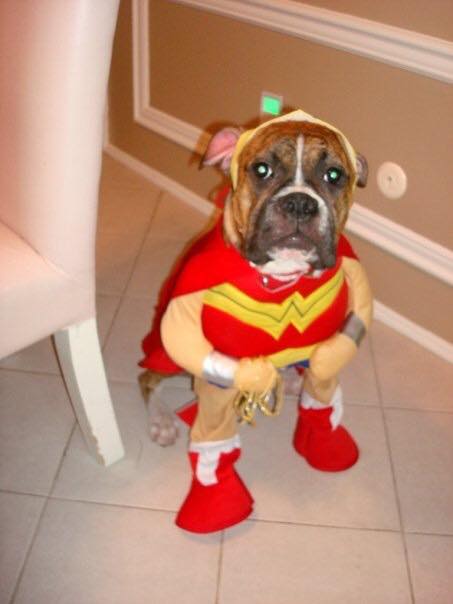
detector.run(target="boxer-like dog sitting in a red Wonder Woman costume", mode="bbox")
[140,110,372,533]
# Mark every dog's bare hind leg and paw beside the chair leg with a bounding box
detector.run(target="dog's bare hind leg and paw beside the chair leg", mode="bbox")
[138,371,179,447]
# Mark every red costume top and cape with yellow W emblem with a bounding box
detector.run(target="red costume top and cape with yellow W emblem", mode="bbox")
[140,210,356,374]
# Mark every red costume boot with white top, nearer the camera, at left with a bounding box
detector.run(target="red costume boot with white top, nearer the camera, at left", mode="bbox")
[176,436,253,533]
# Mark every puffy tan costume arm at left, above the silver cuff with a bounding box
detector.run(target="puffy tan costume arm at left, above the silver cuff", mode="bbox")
[160,290,213,377]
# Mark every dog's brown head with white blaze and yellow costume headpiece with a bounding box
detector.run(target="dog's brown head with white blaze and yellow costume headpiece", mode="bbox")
[203,111,368,273]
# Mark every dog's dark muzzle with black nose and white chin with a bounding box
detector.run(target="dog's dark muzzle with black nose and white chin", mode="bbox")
[245,195,336,272]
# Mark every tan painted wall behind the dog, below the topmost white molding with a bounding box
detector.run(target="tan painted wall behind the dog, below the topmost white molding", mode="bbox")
[110,0,453,341]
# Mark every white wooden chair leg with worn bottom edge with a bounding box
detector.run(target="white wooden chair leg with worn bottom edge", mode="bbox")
[54,318,124,466]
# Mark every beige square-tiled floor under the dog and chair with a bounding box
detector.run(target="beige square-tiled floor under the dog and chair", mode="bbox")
[0,158,453,604]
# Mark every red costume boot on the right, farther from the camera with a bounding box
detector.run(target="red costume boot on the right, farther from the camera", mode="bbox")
[293,387,359,472]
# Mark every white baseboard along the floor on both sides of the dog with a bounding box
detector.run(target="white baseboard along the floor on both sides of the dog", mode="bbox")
[104,143,453,363]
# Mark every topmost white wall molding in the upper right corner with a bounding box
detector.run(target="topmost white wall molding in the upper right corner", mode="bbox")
[171,0,453,83]
